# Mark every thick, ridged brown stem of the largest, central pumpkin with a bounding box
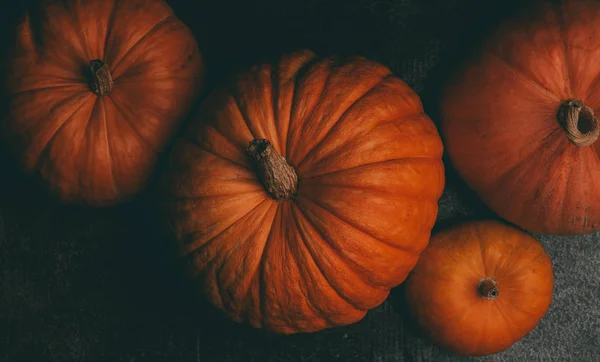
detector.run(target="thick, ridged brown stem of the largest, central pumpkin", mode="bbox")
[246,138,298,201]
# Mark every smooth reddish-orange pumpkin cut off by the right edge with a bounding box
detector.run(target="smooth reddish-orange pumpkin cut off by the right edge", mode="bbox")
[440,0,600,235]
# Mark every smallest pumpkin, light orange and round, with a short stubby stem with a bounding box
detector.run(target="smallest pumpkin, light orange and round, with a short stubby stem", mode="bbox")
[405,221,554,356]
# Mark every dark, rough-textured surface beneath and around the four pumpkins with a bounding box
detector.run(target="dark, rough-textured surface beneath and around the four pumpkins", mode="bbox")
[0,0,600,362]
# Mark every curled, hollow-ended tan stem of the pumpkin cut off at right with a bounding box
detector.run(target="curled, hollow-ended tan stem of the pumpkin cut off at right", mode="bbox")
[557,99,600,147]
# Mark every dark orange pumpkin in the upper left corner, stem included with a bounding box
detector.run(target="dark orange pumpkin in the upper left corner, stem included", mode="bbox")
[5,0,204,206]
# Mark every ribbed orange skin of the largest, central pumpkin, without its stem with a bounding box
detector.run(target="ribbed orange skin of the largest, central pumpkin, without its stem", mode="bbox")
[163,51,444,334]
